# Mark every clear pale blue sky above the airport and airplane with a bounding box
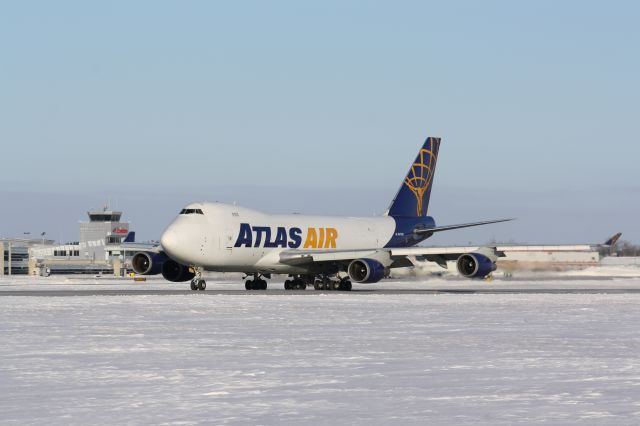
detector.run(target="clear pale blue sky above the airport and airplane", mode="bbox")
[0,1,640,244]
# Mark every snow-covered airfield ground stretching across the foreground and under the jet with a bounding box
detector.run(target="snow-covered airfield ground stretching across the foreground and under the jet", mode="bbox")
[0,264,640,425]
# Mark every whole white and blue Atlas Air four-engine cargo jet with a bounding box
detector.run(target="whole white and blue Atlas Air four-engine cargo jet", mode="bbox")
[132,137,511,291]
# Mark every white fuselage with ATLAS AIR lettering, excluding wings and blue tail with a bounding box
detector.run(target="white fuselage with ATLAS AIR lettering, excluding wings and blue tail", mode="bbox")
[161,203,396,274]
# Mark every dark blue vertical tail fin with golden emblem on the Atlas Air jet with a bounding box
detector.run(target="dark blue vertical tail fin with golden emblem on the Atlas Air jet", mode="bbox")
[387,138,440,217]
